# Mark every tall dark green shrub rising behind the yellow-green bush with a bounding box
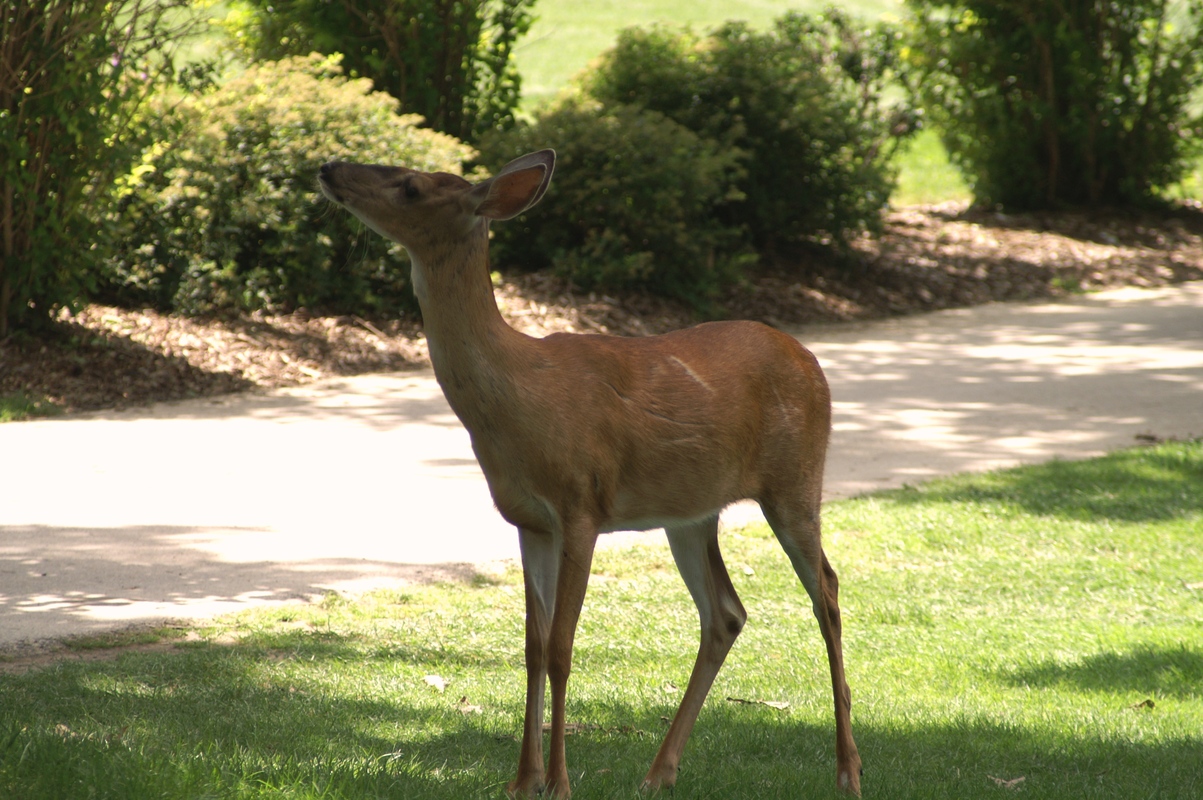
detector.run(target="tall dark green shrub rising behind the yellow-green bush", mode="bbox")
[233,0,534,141]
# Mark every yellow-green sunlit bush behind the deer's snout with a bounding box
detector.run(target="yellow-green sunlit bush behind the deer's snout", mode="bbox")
[106,55,472,314]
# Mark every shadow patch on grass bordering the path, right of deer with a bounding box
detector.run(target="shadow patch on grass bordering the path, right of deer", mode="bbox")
[885,440,1203,522]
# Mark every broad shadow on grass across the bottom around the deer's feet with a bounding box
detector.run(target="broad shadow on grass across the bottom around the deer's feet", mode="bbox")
[0,634,1203,800]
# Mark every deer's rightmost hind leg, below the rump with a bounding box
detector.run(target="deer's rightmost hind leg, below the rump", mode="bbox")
[760,491,860,796]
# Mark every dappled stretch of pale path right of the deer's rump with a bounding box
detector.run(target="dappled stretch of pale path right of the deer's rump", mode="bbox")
[795,284,1203,497]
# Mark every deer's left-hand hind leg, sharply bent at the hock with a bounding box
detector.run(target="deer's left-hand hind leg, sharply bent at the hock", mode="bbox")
[644,515,747,789]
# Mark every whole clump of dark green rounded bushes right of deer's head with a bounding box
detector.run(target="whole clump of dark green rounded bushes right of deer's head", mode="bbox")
[481,10,911,308]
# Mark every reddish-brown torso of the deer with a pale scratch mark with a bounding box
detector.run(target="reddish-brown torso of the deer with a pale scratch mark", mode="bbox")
[473,321,830,529]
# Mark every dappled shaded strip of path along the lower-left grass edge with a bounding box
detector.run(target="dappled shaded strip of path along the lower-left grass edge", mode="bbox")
[0,526,488,644]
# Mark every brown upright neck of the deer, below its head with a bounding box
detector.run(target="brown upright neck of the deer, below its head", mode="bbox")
[410,225,527,434]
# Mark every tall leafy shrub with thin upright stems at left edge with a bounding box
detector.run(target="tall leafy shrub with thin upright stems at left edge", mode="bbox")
[0,0,189,337]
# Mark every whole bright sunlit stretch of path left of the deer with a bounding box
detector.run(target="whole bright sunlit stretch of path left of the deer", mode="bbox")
[0,374,517,644]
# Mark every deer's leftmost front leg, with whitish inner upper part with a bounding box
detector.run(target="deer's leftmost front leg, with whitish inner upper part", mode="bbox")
[506,528,559,798]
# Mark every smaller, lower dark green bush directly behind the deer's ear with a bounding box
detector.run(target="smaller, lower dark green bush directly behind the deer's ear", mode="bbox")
[481,97,749,308]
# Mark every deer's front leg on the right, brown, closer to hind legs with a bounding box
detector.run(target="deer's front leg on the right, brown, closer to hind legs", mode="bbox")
[547,528,598,798]
